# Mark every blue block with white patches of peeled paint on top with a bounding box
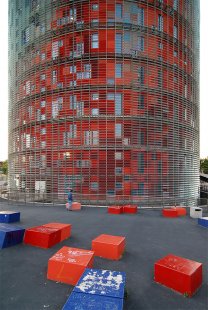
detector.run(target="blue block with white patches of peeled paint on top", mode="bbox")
[74,268,126,298]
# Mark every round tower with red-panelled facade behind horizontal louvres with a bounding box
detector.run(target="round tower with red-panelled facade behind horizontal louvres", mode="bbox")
[9,0,199,206]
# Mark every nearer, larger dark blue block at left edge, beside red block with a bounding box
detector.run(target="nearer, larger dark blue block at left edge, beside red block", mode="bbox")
[0,224,25,249]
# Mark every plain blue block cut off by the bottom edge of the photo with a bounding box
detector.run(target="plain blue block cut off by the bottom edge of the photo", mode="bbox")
[62,292,123,310]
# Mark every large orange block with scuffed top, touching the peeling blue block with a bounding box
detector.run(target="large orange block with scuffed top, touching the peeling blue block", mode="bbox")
[47,247,94,285]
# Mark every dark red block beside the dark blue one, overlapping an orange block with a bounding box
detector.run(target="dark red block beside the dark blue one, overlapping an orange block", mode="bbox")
[24,226,61,249]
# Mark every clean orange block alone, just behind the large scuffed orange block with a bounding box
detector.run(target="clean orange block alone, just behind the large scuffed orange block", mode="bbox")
[92,235,125,260]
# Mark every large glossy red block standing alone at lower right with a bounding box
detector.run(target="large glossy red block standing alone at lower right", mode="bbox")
[154,254,202,297]
